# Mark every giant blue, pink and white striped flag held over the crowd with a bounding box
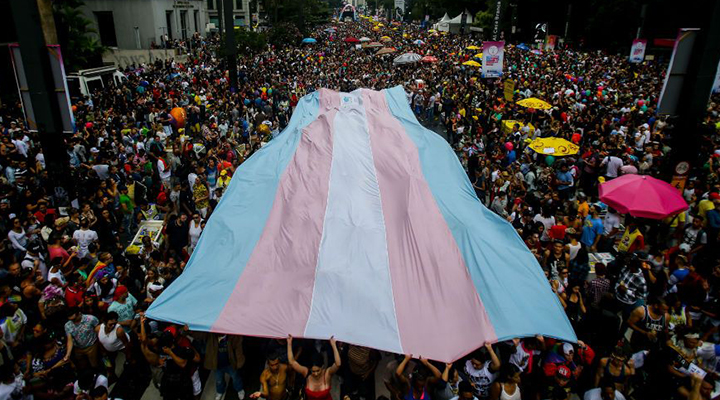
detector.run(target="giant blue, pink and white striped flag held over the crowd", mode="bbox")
[148,87,576,362]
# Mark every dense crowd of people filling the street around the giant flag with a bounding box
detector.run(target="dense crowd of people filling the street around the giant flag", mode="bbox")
[0,7,720,400]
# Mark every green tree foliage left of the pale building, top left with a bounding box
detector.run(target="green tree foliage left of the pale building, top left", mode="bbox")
[53,0,107,71]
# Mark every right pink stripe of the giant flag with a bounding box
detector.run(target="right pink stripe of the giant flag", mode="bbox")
[363,90,502,362]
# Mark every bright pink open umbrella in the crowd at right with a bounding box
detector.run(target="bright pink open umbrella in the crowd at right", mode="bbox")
[600,174,688,219]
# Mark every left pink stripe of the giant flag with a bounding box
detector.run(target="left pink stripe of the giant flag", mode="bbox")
[212,90,340,337]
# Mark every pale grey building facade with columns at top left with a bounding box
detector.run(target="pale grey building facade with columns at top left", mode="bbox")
[82,0,208,49]
